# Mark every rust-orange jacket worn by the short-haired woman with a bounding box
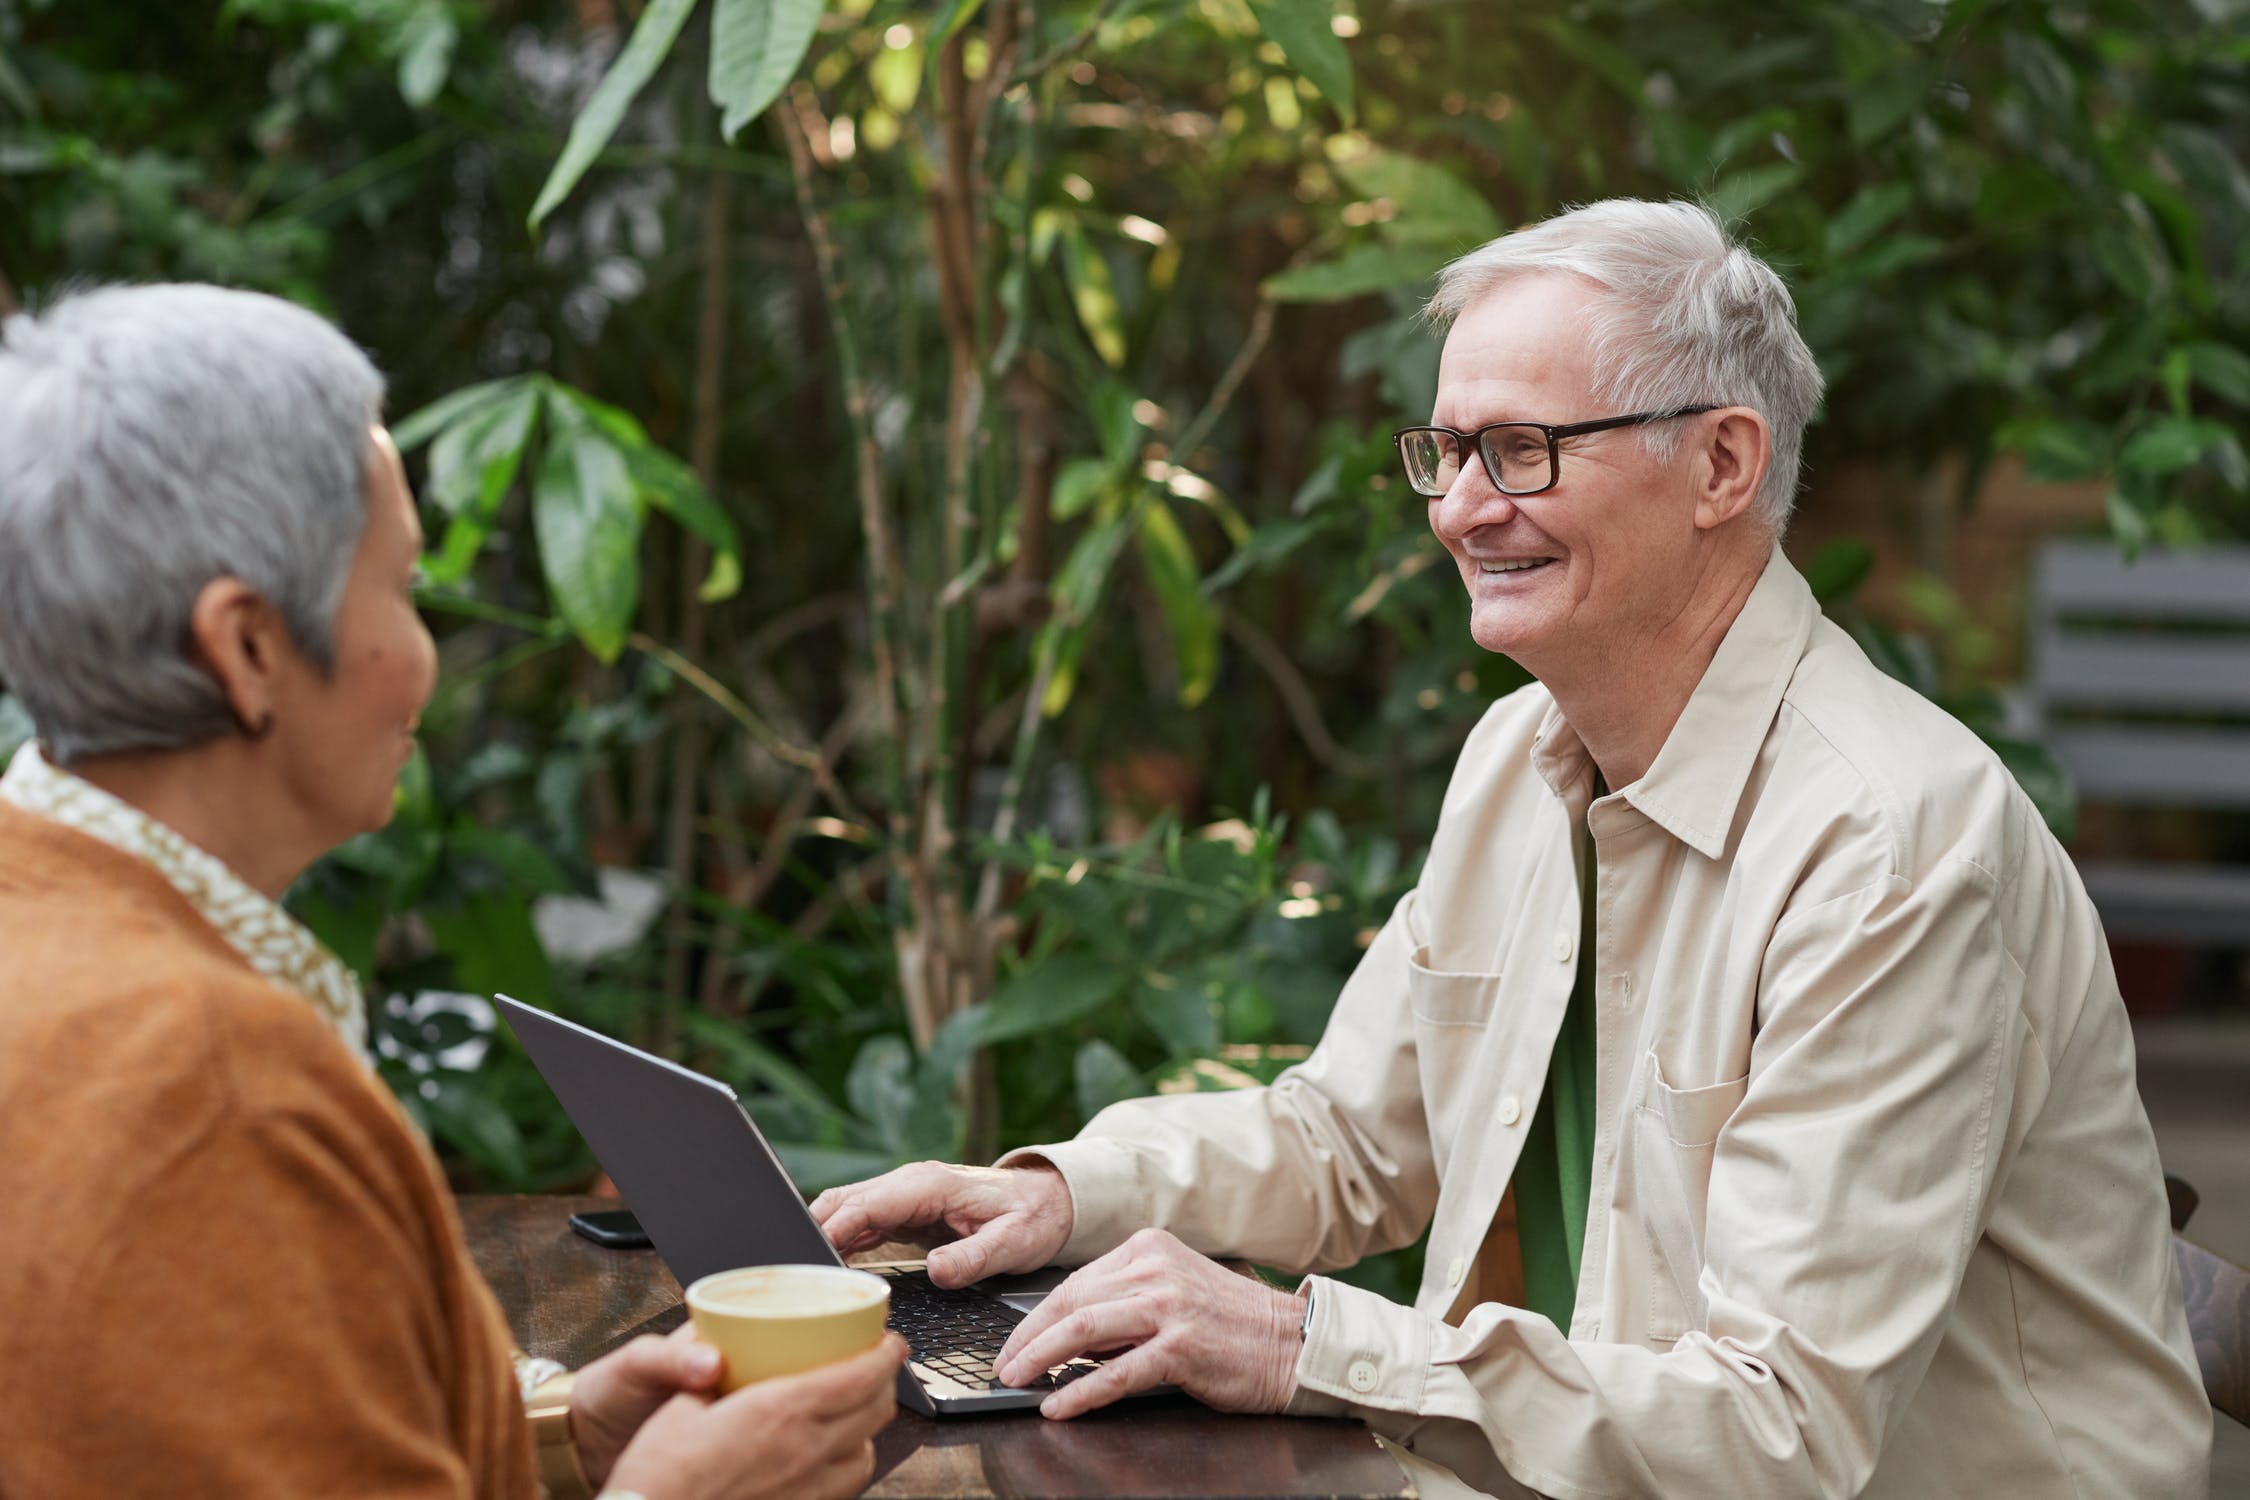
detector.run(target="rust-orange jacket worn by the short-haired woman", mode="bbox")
[0,805,540,1500]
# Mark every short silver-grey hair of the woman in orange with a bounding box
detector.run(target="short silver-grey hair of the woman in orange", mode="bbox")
[0,286,383,765]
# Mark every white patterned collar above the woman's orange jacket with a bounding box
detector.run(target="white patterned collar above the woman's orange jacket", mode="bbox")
[0,742,369,1061]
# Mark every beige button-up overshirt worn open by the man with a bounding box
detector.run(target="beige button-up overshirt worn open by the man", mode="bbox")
[1040,553,2212,1500]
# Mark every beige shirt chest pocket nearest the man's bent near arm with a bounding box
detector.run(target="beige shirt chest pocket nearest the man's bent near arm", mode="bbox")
[1627,1052,1751,1343]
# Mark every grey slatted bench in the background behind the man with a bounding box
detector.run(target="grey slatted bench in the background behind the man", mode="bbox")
[2025,540,2250,947]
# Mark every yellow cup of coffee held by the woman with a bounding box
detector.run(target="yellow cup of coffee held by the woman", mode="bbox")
[686,1266,891,1390]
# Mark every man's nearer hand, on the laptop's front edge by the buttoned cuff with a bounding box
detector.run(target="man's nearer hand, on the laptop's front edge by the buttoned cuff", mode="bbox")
[997,1230,1305,1419]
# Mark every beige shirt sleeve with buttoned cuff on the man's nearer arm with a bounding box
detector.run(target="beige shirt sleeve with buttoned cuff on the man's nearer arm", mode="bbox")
[1294,859,2045,1498]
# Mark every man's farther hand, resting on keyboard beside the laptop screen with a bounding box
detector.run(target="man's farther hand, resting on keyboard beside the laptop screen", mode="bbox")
[812,1160,1071,1286]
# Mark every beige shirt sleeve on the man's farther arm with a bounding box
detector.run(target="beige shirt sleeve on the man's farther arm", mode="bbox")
[1001,895,1438,1271]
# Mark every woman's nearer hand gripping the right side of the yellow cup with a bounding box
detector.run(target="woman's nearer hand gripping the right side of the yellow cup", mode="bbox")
[605,1334,907,1500]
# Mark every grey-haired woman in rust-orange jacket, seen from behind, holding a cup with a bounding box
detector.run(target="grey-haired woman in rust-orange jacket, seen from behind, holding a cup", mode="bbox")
[0,286,902,1500]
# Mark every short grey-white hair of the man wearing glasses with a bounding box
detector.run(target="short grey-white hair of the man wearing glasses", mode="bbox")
[1427,198,1820,535]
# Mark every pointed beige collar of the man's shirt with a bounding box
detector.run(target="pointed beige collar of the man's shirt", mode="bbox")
[1532,546,1820,859]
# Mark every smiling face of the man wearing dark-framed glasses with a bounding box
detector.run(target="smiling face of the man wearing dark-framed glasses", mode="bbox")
[1429,272,1694,672]
